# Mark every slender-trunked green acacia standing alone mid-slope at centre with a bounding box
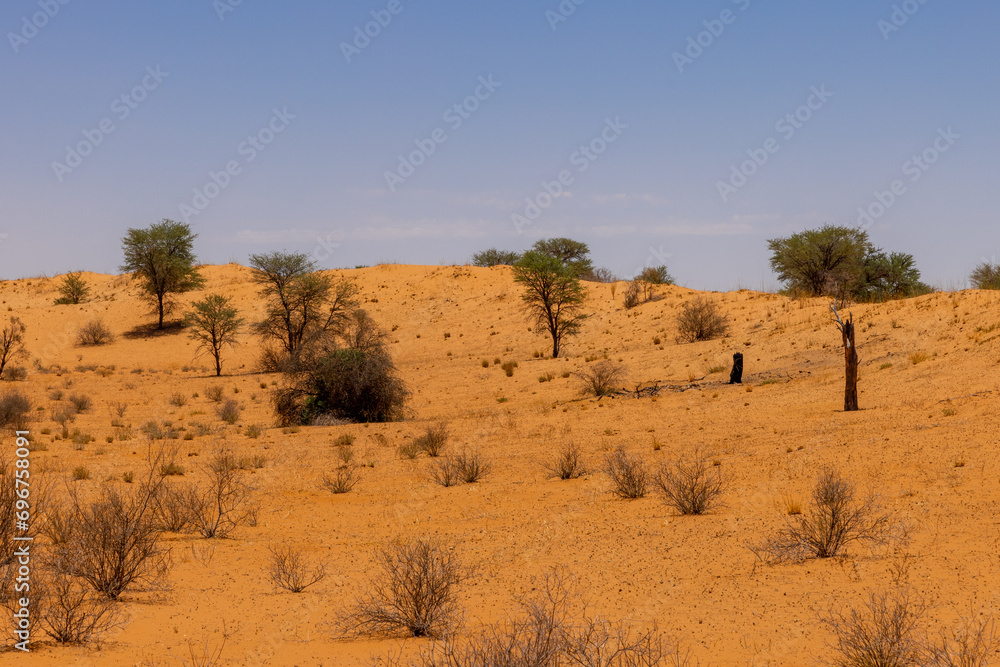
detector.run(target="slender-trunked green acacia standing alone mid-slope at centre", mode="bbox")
[514,250,587,359]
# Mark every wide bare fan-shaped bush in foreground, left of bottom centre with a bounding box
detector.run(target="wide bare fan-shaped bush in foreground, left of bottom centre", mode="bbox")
[341,539,466,637]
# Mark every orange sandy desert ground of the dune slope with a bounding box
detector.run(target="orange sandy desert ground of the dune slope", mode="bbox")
[0,264,1000,667]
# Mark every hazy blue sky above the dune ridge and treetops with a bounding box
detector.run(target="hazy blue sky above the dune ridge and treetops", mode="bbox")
[0,0,1000,290]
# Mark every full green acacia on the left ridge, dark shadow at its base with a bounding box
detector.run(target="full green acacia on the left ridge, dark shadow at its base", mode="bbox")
[119,218,204,329]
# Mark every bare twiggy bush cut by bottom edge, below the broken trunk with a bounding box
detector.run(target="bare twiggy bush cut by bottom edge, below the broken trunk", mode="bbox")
[820,591,927,667]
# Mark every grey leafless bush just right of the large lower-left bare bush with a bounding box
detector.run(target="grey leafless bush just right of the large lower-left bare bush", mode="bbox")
[187,449,254,538]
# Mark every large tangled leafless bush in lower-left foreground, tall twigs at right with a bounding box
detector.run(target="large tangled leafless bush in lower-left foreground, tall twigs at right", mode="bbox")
[62,470,169,600]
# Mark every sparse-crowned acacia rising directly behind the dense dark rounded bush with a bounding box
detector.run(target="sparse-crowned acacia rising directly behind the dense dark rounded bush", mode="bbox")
[250,251,358,366]
